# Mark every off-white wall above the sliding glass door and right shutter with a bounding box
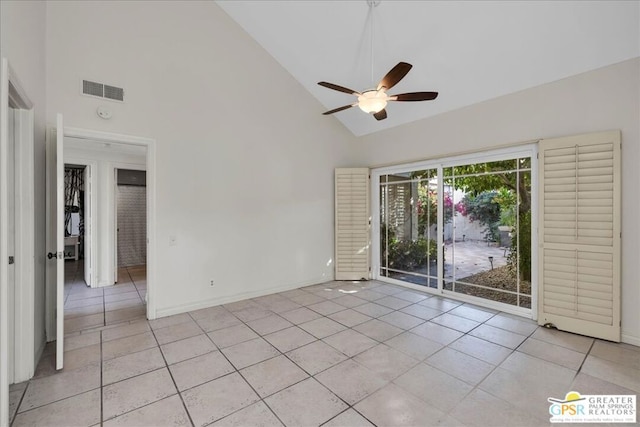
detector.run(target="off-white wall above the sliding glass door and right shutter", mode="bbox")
[357,58,640,345]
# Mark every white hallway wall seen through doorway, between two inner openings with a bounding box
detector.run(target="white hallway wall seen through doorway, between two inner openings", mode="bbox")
[64,137,147,287]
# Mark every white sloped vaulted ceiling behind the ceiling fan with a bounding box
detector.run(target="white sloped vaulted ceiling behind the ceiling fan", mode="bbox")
[217,0,640,136]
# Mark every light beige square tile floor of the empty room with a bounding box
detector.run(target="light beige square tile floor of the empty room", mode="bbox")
[10,273,640,427]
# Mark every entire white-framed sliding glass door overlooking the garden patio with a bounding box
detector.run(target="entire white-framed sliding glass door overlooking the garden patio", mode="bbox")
[373,147,535,309]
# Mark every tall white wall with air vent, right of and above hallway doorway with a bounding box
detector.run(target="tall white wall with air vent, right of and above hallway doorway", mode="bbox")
[46,1,354,316]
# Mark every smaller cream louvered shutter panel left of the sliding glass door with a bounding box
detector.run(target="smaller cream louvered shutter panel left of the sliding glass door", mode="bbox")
[335,168,371,280]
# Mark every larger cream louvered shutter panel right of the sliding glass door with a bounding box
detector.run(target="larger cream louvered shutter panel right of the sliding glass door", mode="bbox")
[538,131,621,342]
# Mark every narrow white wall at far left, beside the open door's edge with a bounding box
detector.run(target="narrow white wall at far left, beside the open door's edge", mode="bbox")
[0,0,47,359]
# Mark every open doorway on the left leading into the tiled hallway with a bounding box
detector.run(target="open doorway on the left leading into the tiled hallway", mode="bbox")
[59,139,147,333]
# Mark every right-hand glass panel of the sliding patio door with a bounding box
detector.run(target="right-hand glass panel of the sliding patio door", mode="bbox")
[444,158,531,308]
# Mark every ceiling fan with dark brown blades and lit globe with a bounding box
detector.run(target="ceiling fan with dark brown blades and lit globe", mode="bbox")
[318,62,438,120]
